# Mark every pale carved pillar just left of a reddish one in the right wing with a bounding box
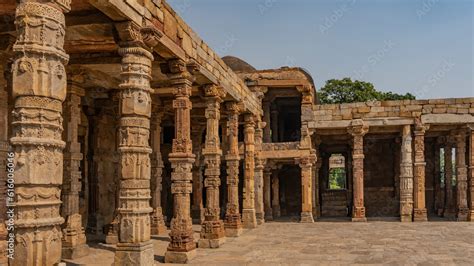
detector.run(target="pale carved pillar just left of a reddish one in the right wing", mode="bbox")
[400,125,413,222]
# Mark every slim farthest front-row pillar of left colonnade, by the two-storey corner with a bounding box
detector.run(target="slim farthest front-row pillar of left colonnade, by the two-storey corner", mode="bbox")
[255,121,266,224]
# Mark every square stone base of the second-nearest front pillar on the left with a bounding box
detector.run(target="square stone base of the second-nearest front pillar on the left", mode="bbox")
[114,241,155,266]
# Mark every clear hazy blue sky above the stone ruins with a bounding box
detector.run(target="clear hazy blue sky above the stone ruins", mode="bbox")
[168,0,474,99]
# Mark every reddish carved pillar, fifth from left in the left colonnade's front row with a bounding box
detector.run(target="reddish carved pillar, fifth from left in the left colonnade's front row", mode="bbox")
[224,102,242,237]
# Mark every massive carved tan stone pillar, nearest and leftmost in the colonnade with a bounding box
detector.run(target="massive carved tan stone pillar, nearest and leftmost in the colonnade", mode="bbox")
[10,1,70,266]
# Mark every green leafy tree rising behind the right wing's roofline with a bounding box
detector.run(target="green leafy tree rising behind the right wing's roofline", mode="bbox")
[318,78,415,104]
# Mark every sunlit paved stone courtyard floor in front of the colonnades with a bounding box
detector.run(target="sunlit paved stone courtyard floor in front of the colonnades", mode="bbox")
[68,221,474,265]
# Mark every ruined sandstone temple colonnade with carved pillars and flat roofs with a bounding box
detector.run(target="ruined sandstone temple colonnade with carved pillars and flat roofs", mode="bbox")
[0,0,474,266]
